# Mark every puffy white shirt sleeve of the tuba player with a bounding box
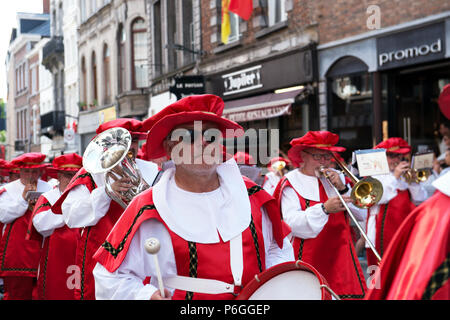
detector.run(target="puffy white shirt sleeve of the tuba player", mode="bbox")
[61,185,111,228]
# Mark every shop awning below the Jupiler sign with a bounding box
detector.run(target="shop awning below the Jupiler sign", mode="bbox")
[223,89,304,122]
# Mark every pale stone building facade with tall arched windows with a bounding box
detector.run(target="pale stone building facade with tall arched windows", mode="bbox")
[78,0,148,150]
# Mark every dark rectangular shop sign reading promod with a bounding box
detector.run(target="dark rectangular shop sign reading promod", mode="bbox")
[377,22,445,70]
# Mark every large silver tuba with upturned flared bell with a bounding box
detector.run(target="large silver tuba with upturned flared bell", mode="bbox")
[83,127,150,209]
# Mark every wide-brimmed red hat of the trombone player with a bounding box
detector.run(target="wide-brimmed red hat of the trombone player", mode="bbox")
[288,131,346,167]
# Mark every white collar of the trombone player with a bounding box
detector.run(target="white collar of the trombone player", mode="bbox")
[286,169,345,202]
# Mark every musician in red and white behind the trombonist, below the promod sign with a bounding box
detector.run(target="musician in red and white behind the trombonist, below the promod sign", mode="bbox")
[366,137,428,266]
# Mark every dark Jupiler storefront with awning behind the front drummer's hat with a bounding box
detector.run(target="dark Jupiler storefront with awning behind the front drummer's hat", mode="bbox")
[206,45,319,160]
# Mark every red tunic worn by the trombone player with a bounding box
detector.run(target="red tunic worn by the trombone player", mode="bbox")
[274,177,367,299]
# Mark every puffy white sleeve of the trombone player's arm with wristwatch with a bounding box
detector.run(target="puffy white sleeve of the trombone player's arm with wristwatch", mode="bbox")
[281,187,328,239]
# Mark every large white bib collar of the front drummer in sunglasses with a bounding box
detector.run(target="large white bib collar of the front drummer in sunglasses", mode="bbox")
[153,158,251,243]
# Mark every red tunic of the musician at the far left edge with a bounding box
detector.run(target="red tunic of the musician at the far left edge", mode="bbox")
[0,189,41,277]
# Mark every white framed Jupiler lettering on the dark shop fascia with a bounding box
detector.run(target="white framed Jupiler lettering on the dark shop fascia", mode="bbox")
[222,65,263,95]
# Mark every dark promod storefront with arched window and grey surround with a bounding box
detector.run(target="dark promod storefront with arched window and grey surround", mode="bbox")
[318,13,450,156]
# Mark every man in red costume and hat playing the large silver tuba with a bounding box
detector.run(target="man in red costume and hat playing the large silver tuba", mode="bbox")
[53,118,158,300]
